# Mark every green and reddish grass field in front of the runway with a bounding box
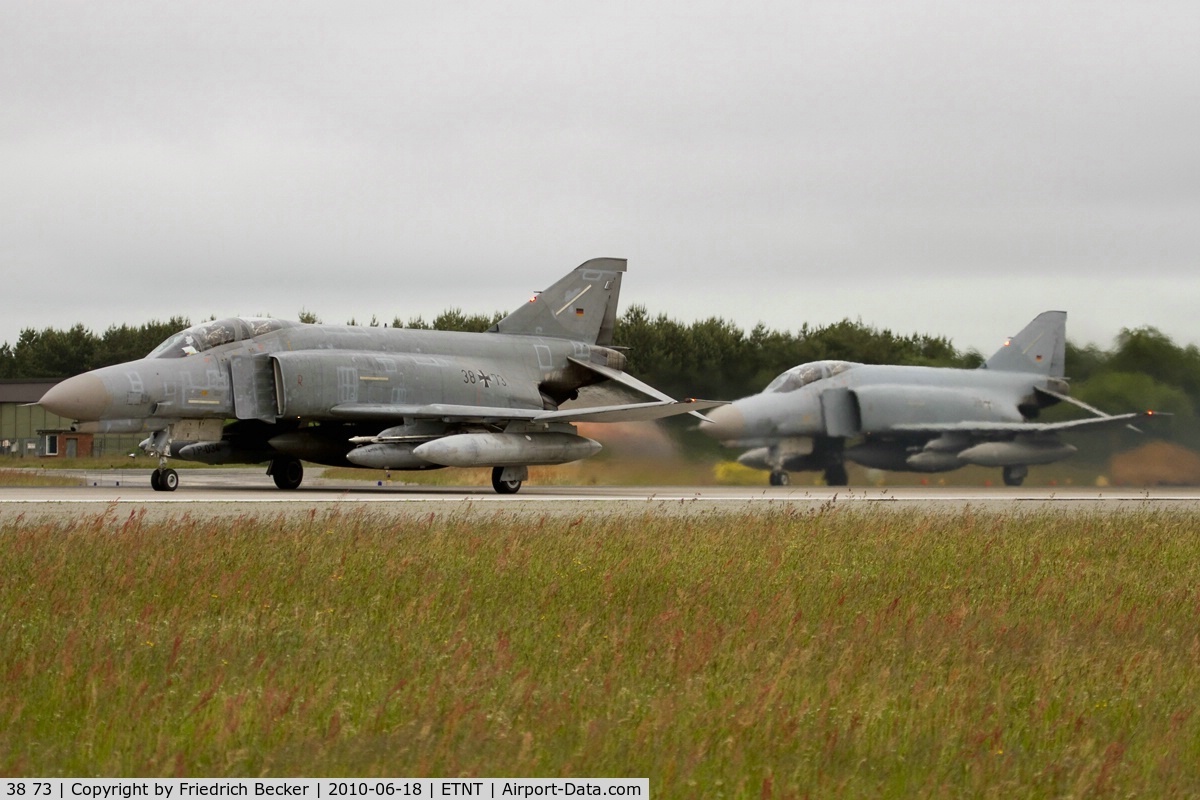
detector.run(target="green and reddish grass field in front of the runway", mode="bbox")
[0,507,1200,798]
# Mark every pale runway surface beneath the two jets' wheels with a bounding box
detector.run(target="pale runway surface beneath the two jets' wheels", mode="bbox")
[0,469,1200,522]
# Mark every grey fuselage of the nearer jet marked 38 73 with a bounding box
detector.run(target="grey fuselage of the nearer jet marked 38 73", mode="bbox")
[42,320,624,432]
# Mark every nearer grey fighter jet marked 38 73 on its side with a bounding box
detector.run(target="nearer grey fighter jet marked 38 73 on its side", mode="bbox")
[40,258,721,494]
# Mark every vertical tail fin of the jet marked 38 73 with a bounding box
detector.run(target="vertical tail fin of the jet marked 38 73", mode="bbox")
[490,258,626,344]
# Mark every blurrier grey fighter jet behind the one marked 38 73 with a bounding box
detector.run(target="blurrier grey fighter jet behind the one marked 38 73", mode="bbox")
[701,311,1152,486]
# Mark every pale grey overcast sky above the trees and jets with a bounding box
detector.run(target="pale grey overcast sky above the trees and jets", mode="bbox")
[0,0,1200,357]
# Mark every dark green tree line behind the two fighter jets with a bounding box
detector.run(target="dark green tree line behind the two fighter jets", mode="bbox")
[0,305,1200,446]
